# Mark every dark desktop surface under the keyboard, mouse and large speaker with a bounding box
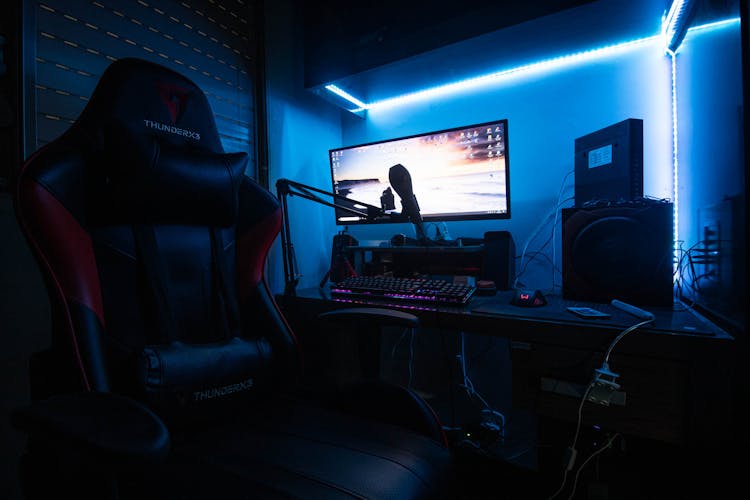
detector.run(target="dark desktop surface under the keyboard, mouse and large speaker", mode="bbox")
[278,286,734,358]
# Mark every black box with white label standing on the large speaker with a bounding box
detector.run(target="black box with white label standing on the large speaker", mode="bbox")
[574,118,643,207]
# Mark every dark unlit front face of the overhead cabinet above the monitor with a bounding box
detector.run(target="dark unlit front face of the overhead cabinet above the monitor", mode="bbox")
[304,0,594,88]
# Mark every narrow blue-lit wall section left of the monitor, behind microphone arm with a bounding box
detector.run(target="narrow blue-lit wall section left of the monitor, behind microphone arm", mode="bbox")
[266,0,341,292]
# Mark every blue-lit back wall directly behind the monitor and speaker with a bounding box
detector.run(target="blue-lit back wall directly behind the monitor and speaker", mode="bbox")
[344,42,671,289]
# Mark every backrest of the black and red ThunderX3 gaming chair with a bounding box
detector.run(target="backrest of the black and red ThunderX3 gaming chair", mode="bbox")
[16,58,298,424]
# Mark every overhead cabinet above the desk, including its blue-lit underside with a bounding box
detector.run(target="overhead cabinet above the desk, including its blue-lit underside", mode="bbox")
[304,0,739,110]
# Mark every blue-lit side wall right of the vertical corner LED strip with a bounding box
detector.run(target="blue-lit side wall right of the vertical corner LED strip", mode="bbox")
[676,22,747,324]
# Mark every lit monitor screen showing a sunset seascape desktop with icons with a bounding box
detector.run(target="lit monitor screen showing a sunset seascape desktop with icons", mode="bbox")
[329,119,510,225]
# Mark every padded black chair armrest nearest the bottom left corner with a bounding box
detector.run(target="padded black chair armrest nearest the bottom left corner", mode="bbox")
[11,392,170,463]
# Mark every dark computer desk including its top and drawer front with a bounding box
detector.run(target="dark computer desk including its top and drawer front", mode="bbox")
[277,286,734,448]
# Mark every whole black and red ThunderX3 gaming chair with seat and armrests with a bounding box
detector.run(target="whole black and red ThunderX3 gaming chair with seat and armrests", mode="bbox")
[13,59,453,499]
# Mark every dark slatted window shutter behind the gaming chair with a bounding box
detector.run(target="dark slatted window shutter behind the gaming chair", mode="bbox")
[26,0,256,176]
